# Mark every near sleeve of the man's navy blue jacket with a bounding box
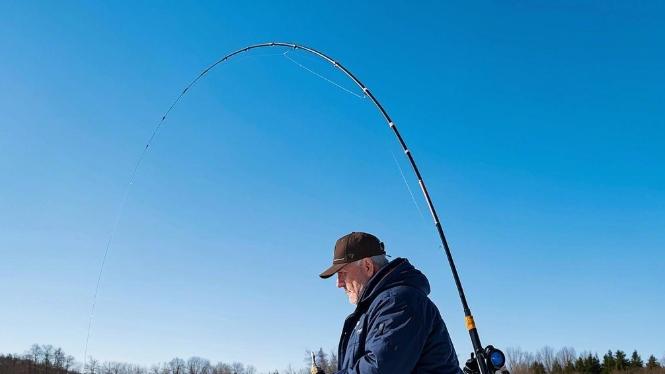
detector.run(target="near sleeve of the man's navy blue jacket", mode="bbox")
[338,292,432,374]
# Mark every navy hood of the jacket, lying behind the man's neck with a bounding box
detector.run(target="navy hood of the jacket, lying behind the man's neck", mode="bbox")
[358,257,430,306]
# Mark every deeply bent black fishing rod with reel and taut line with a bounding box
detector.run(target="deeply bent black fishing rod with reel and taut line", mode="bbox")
[84,42,506,374]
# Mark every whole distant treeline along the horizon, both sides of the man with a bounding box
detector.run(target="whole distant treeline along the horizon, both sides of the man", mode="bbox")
[0,344,665,374]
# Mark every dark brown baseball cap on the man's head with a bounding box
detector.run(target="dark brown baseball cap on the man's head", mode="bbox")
[319,232,386,279]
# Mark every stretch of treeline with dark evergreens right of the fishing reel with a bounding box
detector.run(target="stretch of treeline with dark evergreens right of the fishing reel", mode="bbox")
[506,346,665,374]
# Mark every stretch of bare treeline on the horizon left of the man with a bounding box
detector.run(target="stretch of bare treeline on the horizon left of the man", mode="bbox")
[0,344,337,374]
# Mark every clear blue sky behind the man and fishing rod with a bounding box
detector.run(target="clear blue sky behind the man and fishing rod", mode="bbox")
[0,1,665,370]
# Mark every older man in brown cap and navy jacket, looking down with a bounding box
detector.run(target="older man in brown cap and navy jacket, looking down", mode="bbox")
[312,232,461,374]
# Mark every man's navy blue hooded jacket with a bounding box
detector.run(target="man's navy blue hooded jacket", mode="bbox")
[338,258,462,374]
